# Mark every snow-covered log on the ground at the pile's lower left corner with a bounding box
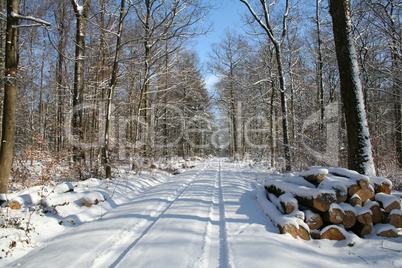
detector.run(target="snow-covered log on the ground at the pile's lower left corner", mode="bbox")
[257,187,310,239]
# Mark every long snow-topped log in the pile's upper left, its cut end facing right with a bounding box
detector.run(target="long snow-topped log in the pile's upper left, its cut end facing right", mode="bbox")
[265,180,336,212]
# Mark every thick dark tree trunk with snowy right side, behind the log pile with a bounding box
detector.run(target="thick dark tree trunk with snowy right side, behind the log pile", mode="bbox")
[329,0,375,176]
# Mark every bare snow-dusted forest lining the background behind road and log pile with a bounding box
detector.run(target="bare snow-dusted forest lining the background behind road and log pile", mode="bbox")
[0,0,402,193]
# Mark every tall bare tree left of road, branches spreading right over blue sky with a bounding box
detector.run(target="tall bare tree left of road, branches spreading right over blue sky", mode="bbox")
[130,0,208,156]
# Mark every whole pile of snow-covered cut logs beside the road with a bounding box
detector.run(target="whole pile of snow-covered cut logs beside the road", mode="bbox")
[257,167,402,240]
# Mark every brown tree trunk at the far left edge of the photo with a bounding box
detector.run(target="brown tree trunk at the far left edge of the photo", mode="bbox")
[0,0,18,193]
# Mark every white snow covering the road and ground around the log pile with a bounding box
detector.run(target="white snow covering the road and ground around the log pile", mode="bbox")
[0,159,402,267]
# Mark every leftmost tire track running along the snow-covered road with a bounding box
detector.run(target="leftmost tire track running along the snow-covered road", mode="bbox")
[102,163,209,267]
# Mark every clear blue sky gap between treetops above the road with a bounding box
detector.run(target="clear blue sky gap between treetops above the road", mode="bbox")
[194,0,247,89]
